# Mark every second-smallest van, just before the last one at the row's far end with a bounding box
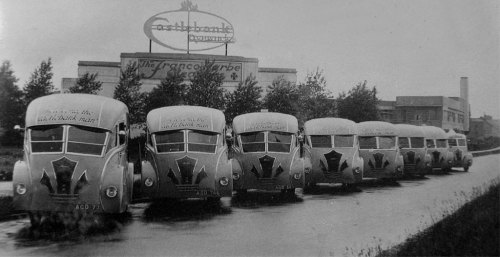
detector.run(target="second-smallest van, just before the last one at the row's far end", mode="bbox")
[421,126,453,172]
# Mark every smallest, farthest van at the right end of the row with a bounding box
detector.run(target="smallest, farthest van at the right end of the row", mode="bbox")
[447,130,472,171]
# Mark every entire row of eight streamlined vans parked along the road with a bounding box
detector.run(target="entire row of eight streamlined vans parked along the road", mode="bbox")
[13,94,472,220]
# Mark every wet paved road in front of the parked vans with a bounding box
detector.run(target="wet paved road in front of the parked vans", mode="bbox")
[0,155,500,256]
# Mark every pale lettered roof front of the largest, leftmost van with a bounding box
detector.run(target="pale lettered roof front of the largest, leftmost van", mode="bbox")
[26,94,128,130]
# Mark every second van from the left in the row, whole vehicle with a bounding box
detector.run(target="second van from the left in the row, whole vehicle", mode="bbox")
[142,106,233,200]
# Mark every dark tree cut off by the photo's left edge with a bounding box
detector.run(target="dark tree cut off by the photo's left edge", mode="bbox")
[0,61,26,145]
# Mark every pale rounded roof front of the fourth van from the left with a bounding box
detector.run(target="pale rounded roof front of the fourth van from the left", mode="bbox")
[304,118,358,135]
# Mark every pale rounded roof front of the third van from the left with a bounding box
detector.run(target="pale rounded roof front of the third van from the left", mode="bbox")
[233,112,299,134]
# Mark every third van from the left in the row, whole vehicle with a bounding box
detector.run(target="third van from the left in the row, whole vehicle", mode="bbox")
[233,112,311,194]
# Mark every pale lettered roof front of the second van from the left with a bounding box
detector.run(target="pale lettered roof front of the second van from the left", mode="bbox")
[146,105,226,133]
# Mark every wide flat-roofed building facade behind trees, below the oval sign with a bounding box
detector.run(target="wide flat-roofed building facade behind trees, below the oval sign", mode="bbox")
[61,53,297,97]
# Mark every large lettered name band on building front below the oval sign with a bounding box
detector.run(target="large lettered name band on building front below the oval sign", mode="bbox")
[138,59,242,82]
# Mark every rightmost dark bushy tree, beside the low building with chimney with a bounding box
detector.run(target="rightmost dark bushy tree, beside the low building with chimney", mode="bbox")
[337,80,378,122]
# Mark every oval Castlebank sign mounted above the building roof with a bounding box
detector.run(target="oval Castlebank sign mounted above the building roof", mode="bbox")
[144,0,234,53]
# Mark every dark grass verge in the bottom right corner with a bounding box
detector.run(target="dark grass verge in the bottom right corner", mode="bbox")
[377,183,500,256]
